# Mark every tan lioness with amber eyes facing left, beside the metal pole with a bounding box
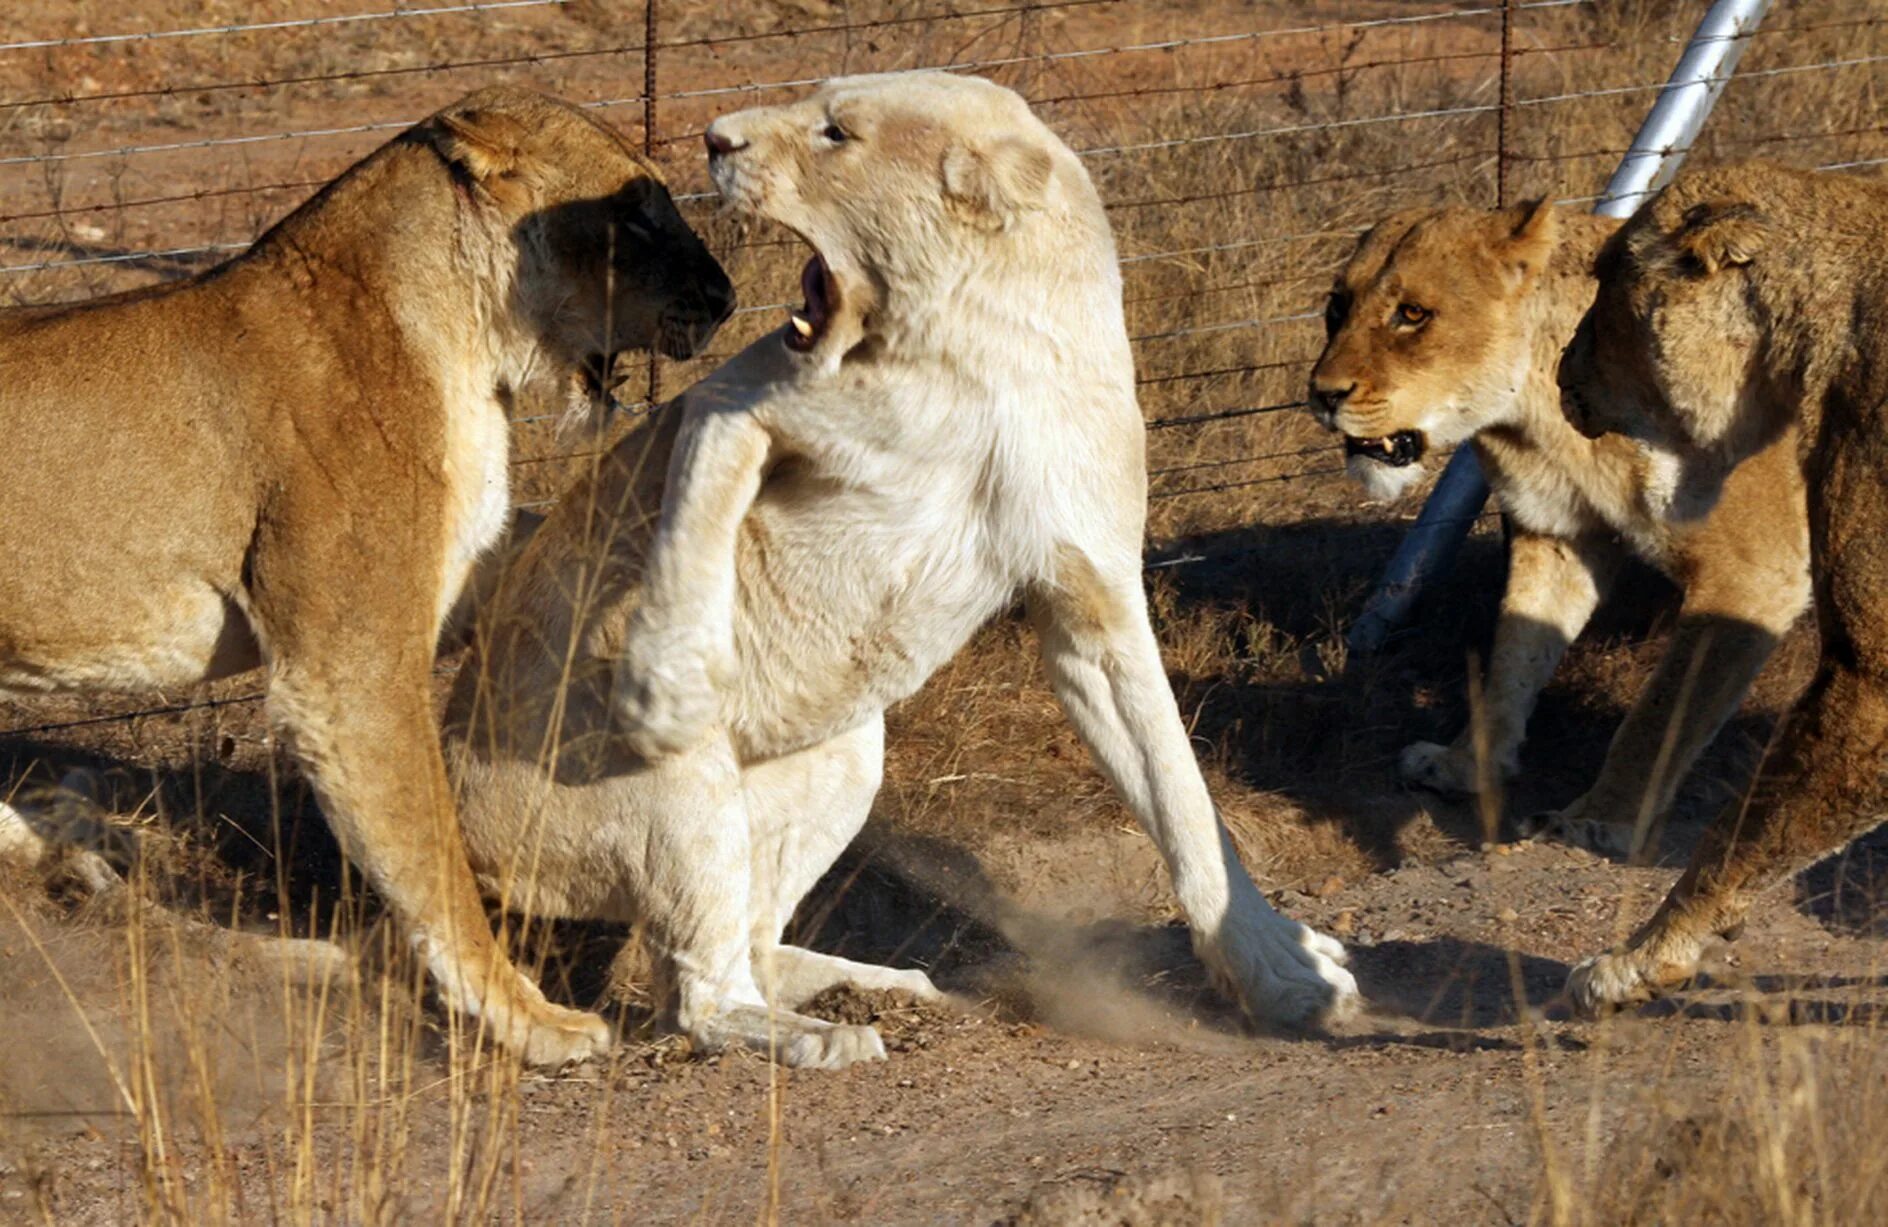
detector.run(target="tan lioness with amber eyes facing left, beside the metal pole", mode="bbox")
[1310,204,1809,853]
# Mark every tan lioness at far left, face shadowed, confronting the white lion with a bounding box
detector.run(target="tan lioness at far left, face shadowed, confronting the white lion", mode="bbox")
[0,89,733,1063]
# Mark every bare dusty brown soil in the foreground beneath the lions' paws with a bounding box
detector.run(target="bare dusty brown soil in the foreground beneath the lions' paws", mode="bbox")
[11,815,1884,1223]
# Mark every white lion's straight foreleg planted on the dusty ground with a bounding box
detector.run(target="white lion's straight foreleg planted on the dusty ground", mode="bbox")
[1029,549,1357,1023]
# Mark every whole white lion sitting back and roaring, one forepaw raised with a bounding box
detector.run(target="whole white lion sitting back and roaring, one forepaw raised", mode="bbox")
[449,74,1357,1067]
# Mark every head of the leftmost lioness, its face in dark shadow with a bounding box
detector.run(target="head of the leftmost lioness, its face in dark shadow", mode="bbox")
[413,87,734,402]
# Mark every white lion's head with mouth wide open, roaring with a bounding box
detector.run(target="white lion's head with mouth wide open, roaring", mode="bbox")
[706,72,1118,366]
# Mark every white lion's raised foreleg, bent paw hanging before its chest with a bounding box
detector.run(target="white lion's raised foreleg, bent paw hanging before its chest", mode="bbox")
[612,396,772,761]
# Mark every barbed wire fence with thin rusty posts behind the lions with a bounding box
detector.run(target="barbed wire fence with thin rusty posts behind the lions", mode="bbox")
[0,0,1888,749]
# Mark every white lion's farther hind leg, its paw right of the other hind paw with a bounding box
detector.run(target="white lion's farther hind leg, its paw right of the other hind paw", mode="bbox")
[742,715,942,1010]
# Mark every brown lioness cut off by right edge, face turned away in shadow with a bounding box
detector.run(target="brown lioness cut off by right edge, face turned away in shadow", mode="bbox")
[1561,162,1888,1010]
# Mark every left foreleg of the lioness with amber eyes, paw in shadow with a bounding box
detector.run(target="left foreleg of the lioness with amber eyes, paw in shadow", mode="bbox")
[1397,532,1620,797]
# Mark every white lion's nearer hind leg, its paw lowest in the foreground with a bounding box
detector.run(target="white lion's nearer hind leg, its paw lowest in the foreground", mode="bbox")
[632,740,885,1068]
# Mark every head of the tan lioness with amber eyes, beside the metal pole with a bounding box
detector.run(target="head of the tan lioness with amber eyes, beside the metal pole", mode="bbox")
[1310,202,1558,498]
